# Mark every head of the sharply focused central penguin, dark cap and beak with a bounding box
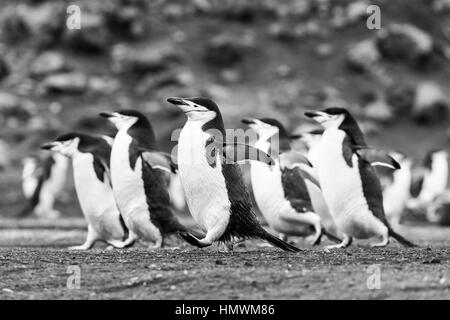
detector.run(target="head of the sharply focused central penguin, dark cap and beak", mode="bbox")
[167,97,220,123]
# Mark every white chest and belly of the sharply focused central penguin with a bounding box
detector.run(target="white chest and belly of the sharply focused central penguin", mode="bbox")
[178,121,231,231]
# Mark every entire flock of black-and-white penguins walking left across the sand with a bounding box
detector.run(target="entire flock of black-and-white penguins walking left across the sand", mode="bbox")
[14,97,448,252]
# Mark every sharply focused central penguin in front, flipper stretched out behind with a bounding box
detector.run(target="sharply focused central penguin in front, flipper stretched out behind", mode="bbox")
[167,98,299,252]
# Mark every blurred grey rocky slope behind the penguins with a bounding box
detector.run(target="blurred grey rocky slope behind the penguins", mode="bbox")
[0,0,450,215]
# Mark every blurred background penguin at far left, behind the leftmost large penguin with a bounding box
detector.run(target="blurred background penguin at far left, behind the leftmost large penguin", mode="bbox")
[16,152,68,219]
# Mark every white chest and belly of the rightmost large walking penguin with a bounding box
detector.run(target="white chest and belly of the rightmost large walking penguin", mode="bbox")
[317,128,382,238]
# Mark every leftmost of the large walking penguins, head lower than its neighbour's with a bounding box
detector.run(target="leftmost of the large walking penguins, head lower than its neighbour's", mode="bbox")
[41,133,127,250]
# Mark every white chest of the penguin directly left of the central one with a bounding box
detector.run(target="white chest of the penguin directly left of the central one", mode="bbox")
[111,130,148,221]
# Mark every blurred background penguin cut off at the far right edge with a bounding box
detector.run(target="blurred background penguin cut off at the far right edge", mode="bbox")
[408,149,449,209]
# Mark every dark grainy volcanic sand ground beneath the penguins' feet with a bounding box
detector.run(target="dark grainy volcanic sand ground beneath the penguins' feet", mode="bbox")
[0,221,450,299]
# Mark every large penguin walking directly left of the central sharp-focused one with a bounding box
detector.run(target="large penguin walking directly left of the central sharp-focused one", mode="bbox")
[100,110,196,249]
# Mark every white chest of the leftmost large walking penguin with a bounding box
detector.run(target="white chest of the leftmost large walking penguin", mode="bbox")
[72,153,123,239]
